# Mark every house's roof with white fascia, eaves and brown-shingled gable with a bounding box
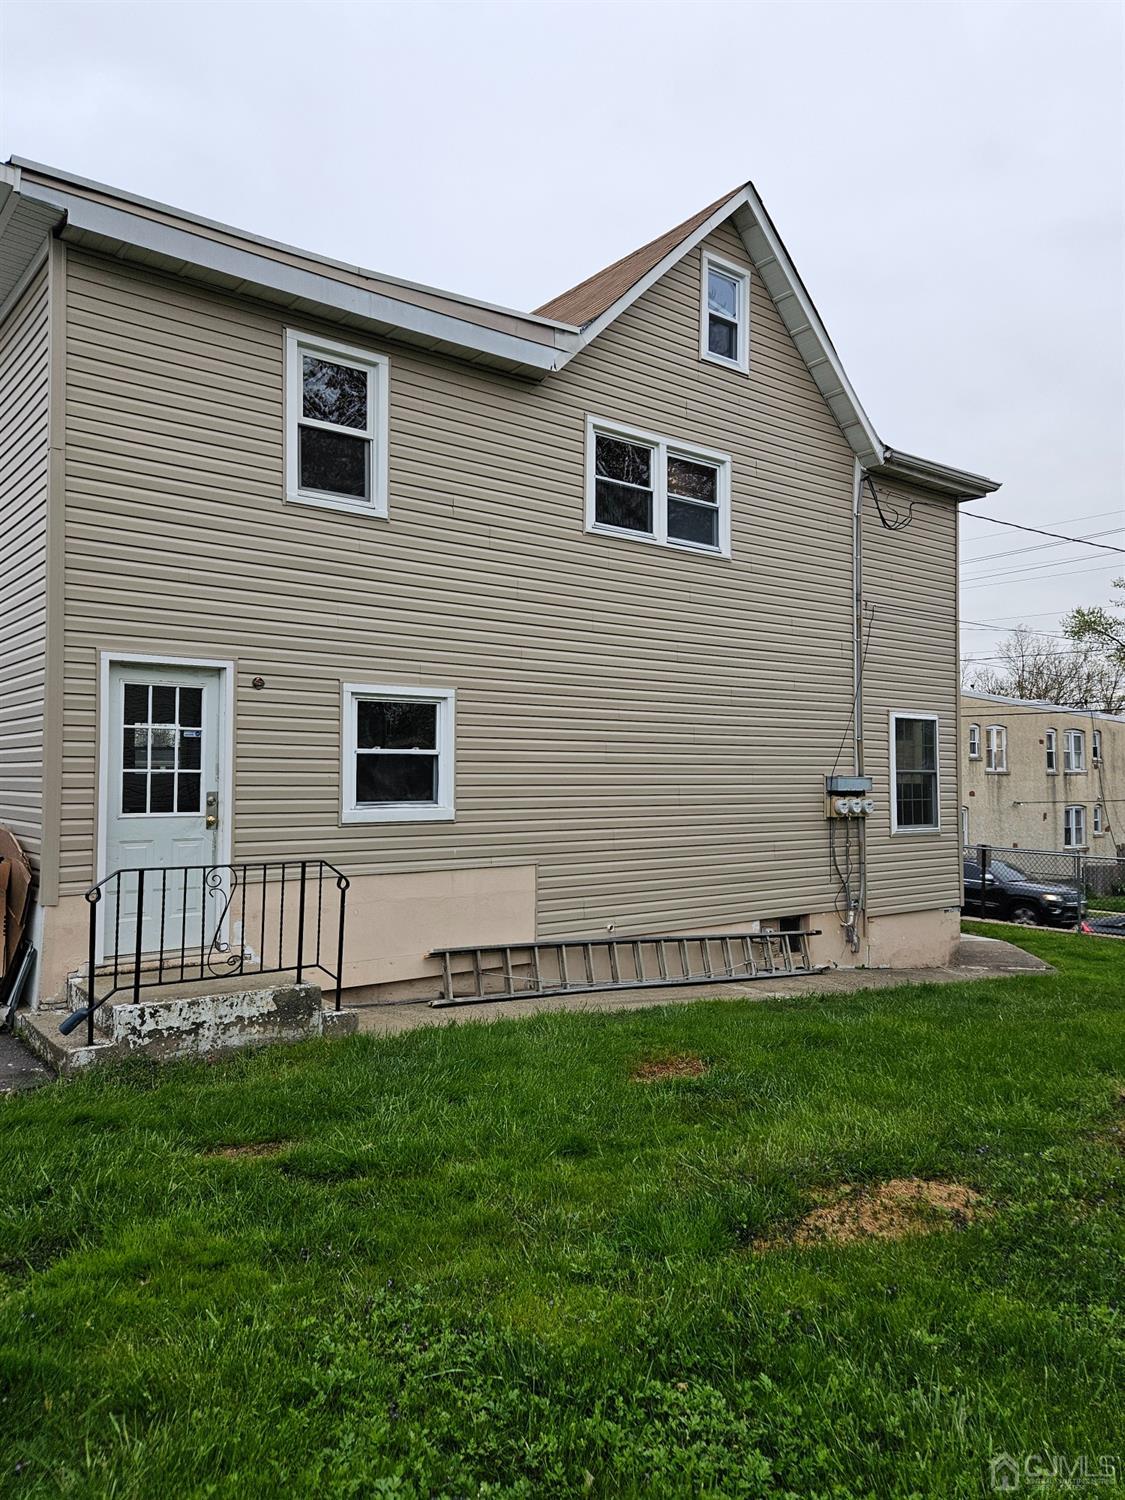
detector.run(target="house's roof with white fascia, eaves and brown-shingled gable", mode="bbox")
[0,156,999,500]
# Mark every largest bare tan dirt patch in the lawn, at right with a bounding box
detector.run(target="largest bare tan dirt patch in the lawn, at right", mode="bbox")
[755,1178,984,1250]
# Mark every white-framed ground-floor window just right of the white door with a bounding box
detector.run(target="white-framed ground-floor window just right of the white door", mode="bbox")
[341,683,455,824]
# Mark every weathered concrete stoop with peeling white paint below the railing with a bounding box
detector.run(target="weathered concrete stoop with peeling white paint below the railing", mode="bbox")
[17,983,357,1073]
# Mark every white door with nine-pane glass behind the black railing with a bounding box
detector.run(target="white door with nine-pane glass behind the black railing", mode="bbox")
[102,663,227,959]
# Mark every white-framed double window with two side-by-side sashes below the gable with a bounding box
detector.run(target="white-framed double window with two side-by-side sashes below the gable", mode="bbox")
[587,417,731,557]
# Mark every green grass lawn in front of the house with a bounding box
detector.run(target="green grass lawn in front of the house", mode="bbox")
[0,927,1125,1500]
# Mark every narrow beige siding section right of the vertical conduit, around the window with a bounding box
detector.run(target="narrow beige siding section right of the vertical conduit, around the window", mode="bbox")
[863,485,960,917]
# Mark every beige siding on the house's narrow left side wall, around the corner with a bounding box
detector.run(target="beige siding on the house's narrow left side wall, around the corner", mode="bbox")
[0,266,48,869]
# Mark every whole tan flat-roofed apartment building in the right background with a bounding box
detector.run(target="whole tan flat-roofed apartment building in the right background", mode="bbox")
[962,693,1125,857]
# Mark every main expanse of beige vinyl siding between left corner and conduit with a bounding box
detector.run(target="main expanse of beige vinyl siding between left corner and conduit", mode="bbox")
[63,217,953,935]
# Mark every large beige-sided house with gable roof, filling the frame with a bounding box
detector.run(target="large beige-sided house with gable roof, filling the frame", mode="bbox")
[0,161,996,996]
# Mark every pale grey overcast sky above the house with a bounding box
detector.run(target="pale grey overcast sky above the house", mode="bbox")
[0,0,1125,669]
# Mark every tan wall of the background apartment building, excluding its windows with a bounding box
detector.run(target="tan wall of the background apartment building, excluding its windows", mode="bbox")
[960,693,1125,857]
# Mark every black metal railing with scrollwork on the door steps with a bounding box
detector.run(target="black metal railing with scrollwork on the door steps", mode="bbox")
[59,860,351,1044]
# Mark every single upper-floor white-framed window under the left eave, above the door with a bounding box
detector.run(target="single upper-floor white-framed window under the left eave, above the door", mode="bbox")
[285,329,390,516]
